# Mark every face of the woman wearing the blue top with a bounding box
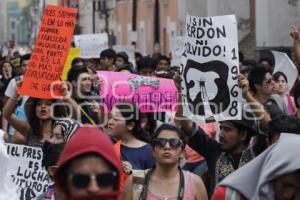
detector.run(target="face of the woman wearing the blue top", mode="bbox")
[108,107,128,137]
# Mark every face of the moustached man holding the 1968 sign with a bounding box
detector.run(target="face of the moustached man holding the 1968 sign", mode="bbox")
[220,121,243,153]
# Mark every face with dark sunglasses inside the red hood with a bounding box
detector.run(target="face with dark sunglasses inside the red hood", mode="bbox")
[67,155,117,198]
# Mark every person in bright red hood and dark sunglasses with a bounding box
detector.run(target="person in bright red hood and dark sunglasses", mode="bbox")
[54,127,121,200]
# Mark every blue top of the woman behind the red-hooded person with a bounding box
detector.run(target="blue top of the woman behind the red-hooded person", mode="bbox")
[121,144,155,169]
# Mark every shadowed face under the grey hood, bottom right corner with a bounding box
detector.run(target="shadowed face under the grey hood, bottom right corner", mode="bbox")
[273,173,300,200]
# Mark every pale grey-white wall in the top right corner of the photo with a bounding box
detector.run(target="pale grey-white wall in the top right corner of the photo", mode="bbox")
[256,0,300,47]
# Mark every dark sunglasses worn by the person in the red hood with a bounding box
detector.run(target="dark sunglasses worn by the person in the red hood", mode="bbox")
[69,172,118,189]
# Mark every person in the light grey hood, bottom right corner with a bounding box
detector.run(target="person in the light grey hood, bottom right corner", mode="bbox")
[212,134,300,200]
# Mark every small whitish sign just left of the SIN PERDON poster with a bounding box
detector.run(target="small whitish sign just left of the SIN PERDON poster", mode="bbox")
[170,36,185,66]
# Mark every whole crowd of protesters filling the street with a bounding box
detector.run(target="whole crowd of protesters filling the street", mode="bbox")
[0,23,300,200]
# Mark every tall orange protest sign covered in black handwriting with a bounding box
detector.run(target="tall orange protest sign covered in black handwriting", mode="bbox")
[19,5,77,99]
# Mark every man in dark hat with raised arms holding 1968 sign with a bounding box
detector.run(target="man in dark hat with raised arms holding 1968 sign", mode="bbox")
[175,75,269,195]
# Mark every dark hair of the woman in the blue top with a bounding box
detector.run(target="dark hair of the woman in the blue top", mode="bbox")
[114,102,150,143]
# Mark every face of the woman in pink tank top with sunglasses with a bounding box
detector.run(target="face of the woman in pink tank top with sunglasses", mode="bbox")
[153,130,183,165]
